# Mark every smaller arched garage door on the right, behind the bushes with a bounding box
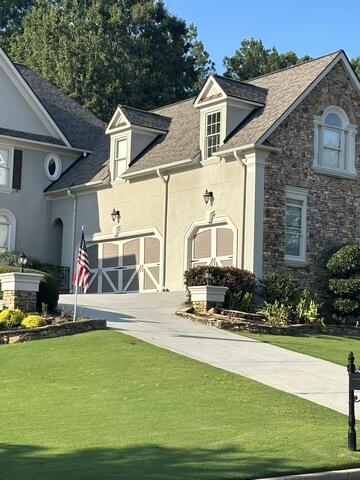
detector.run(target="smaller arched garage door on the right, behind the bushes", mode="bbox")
[191,226,235,267]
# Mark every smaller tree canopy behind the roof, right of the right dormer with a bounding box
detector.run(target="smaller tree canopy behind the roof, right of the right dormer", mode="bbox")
[224,38,311,80]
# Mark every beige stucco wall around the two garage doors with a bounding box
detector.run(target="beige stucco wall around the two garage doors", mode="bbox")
[52,160,244,290]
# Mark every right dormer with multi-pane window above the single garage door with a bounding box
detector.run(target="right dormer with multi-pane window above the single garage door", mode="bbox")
[194,75,267,160]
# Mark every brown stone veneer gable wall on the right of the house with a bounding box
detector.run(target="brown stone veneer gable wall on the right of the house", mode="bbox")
[263,63,360,289]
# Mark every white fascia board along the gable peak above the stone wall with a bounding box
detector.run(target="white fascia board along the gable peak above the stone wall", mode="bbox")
[257,51,354,143]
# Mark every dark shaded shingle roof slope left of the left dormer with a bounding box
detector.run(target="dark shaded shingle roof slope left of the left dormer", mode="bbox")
[14,63,105,150]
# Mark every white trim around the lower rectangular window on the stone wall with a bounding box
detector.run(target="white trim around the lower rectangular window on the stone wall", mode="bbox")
[284,186,308,265]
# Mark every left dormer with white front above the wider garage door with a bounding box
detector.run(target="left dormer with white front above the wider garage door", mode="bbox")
[106,105,171,181]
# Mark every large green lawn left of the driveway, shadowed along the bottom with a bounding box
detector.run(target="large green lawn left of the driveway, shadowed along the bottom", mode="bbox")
[0,331,360,480]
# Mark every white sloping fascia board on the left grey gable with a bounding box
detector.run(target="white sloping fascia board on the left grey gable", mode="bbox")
[0,48,71,147]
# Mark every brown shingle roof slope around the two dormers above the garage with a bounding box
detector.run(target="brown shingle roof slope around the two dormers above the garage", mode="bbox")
[48,52,339,191]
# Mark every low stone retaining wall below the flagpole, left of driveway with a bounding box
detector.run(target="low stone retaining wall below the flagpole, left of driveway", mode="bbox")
[0,320,106,344]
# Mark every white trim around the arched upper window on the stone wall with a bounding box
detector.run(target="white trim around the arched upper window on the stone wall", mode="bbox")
[313,105,357,178]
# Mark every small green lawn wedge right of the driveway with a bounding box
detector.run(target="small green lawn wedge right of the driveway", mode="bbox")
[241,332,360,366]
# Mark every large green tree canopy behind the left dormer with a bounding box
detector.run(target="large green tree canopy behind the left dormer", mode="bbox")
[10,0,213,120]
